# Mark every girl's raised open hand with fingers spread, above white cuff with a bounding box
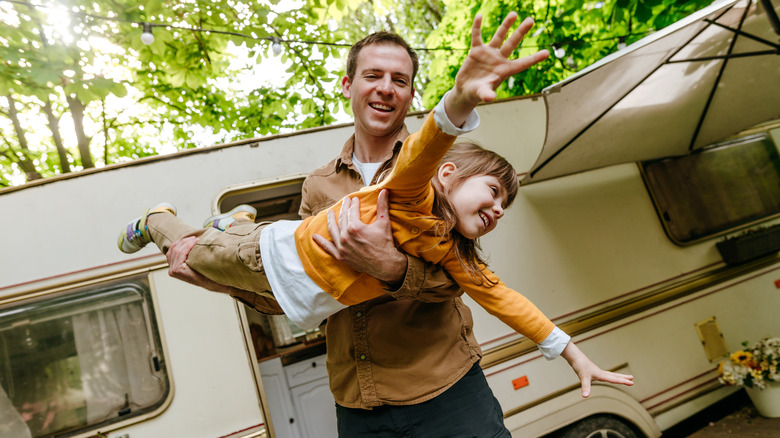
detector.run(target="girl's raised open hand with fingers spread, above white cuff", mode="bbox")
[444,12,550,126]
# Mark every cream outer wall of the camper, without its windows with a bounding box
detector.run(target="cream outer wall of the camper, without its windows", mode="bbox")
[0,96,780,438]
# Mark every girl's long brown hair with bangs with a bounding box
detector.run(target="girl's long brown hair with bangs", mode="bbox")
[433,140,519,286]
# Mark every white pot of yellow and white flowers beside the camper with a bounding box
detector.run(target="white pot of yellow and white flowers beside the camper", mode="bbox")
[718,338,780,418]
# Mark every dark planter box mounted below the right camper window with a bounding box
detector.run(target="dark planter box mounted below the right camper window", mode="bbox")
[715,224,780,265]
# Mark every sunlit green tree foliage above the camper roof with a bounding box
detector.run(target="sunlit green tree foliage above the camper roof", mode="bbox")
[0,0,720,187]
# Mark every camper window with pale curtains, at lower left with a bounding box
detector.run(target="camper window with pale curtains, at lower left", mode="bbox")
[0,278,169,437]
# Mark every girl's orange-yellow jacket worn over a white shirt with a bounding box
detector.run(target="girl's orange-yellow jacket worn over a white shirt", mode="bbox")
[295,112,554,343]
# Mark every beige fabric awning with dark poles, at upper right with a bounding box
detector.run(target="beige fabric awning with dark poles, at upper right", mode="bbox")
[523,0,780,183]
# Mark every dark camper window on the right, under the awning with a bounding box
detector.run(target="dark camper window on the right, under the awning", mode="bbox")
[642,135,780,244]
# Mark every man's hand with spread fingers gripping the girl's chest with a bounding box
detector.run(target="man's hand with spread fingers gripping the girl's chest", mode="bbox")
[314,190,407,285]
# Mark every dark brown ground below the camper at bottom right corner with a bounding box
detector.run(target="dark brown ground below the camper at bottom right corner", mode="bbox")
[661,391,780,438]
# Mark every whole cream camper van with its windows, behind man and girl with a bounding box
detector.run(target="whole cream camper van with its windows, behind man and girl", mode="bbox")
[0,87,780,438]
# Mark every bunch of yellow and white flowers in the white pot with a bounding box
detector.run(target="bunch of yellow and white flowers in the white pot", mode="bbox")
[718,338,780,389]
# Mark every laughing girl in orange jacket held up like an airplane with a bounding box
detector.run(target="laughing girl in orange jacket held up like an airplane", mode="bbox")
[119,15,632,395]
